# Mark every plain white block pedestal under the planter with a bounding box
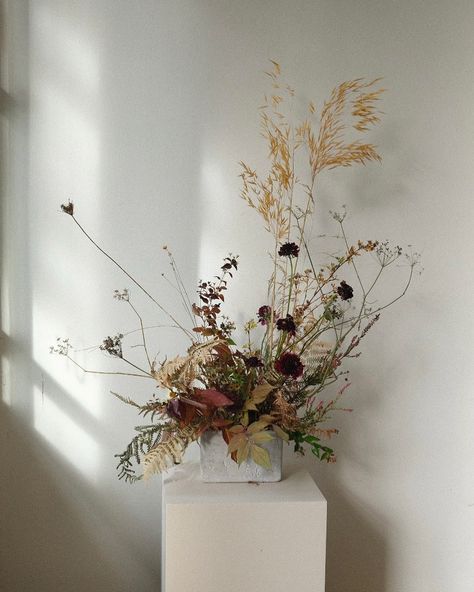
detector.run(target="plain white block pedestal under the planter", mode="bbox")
[162,464,326,592]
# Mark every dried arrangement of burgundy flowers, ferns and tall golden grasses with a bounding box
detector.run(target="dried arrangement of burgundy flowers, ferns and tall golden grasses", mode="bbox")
[51,62,418,482]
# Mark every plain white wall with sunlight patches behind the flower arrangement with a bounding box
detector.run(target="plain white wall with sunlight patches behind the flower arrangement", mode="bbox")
[0,0,474,592]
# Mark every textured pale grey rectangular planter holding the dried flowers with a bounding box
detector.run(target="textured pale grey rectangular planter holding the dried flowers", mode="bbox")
[199,431,283,483]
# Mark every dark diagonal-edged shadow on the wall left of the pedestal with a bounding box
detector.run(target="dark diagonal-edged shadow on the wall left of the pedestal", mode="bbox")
[0,404,159,592]
